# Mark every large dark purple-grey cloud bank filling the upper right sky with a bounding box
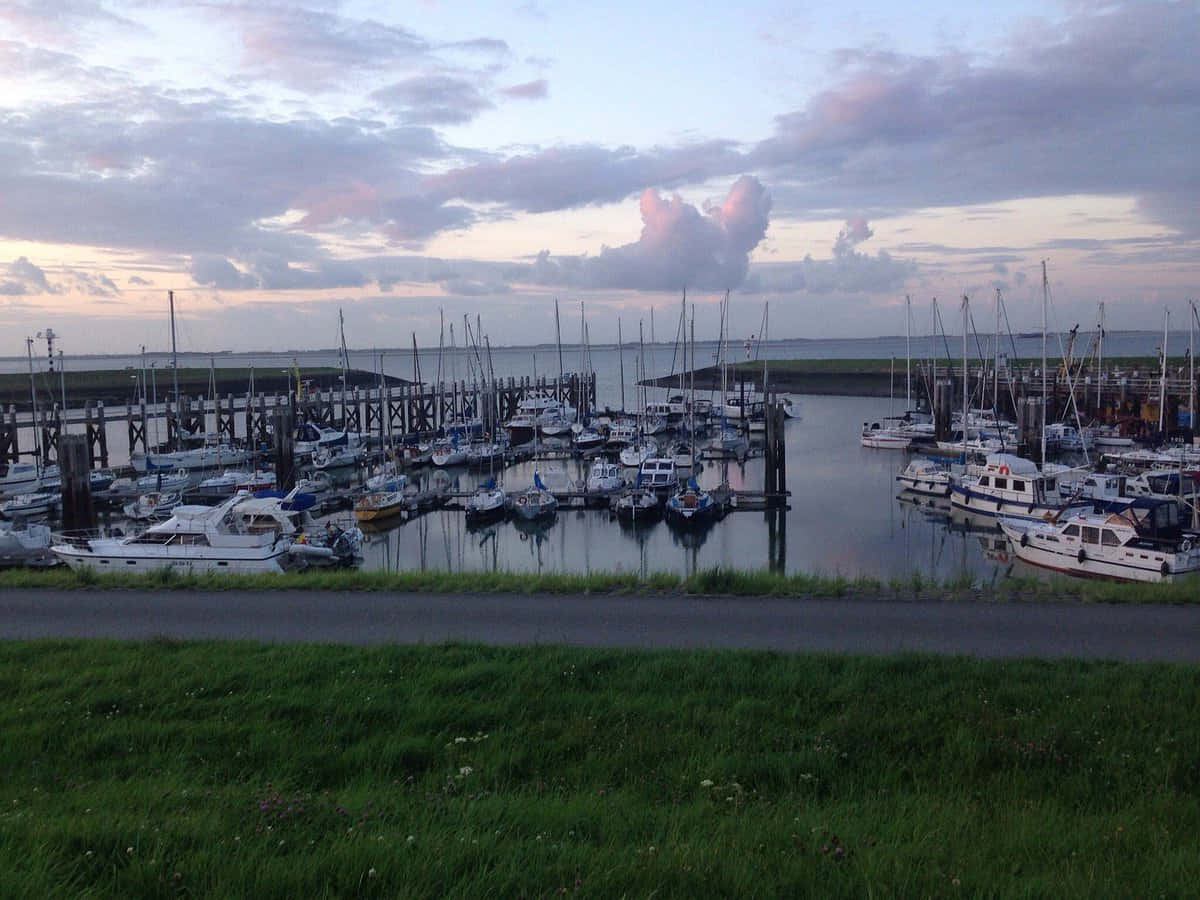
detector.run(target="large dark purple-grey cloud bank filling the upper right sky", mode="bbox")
[750,2,1200,230]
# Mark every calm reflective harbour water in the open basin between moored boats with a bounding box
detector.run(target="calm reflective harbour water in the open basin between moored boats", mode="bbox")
[352,396,1007,580]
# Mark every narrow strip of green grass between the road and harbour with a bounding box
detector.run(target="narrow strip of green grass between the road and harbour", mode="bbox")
[0,566,1200,604]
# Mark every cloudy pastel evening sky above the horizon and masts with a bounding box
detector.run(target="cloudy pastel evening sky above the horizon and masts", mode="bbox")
[0,0,1200,355]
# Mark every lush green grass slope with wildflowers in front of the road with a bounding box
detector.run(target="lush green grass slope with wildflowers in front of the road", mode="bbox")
[0,642,1200,900]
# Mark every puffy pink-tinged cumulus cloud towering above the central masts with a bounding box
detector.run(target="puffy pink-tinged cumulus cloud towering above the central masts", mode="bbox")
[511,175,770,290]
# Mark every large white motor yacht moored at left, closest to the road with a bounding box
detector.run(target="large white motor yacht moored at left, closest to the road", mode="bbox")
[50,494,292,572]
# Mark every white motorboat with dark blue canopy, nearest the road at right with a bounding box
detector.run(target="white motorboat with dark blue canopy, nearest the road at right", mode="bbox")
[1000,497,1200,582]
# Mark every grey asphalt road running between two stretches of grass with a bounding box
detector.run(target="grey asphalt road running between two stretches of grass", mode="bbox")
[0,589,1200,662]
